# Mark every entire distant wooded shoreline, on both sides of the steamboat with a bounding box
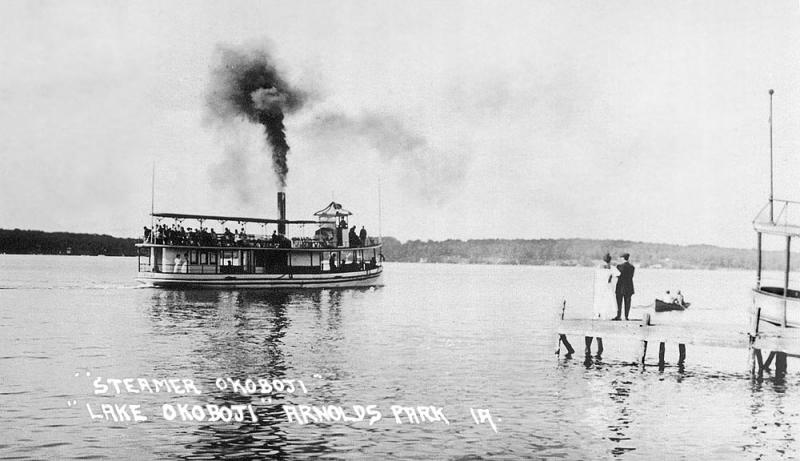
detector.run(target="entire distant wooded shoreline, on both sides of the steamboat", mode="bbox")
[0,229,800,270]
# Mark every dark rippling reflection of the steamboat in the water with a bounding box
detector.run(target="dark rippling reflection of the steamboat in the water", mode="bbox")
[150,289,368,459]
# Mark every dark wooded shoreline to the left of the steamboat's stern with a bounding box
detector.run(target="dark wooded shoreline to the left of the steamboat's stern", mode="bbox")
[0,229,137,256]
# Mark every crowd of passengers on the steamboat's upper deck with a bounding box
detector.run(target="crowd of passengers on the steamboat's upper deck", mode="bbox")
[144,220,368,248]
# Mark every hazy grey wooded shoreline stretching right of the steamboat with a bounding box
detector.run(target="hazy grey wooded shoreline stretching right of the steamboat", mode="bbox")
[384,237,800,270]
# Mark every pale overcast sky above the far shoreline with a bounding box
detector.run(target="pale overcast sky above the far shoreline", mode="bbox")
[0,0,800,248]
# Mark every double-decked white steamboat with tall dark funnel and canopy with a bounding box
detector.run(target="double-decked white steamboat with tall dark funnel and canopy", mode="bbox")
[136,192,384,288]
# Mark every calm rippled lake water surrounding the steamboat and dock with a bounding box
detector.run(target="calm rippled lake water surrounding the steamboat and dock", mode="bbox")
[0,255,800,459]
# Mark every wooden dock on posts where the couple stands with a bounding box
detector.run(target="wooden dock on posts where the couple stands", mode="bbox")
[556,305,800,373]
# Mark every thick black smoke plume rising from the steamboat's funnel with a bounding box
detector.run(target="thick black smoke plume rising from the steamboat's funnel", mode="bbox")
[208,47,305,188]
